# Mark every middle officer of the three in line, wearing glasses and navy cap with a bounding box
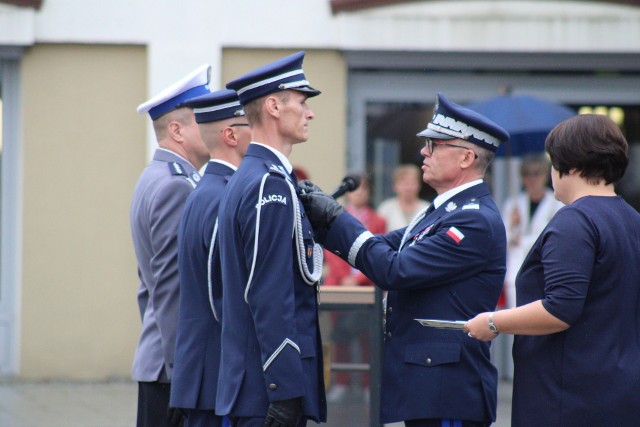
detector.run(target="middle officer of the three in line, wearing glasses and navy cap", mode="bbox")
[171,90,251,427]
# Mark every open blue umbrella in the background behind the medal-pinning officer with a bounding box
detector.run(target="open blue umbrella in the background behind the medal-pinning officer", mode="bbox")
[467,95,576,156]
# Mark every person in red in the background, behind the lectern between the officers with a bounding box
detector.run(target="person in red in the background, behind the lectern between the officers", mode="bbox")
[323,174,386,402]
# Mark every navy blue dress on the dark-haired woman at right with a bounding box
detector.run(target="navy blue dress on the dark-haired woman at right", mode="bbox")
[512,196,640,427]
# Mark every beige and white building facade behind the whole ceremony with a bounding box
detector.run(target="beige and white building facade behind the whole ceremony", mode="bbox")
[0,0,640,379]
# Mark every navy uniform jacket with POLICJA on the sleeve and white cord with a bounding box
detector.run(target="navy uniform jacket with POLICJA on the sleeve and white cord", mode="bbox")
[216,144,326,420]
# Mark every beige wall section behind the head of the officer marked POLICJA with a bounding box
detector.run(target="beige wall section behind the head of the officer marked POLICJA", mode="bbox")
[221,48,347,191]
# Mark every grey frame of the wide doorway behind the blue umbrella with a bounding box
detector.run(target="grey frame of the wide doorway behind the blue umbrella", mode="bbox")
[345,51,640,207]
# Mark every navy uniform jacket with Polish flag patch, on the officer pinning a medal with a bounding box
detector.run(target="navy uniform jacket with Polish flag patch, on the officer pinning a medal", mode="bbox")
[325,183,506,423]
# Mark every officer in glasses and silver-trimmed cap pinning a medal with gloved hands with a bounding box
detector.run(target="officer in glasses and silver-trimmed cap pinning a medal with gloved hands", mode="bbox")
[301,94,509,427]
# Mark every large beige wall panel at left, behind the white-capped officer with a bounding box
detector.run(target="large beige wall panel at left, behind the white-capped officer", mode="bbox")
[19,45,147,379]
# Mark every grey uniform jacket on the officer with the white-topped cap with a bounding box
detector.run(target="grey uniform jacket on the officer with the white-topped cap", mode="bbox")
[130,148,200,382]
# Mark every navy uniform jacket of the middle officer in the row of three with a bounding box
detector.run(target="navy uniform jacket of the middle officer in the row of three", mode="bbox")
[171,161,234,418]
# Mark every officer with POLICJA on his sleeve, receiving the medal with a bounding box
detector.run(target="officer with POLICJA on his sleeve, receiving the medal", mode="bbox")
[216,52,326,427]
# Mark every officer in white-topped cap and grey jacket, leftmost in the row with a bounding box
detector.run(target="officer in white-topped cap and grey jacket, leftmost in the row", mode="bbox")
[130,65,211,427]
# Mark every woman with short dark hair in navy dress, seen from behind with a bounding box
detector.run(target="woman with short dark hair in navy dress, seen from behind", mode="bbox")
[465,115,640,427]
